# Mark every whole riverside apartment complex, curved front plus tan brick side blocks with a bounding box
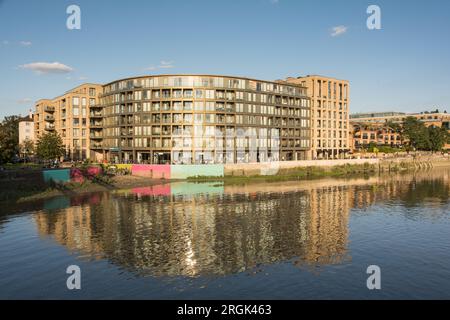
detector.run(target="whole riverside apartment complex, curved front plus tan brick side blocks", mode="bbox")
[35,75,349,164]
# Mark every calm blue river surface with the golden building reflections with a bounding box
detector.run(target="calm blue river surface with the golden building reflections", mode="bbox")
[0,169,450,299]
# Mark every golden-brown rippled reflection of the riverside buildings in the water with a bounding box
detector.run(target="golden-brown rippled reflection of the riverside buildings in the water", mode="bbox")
[35,171,449,276]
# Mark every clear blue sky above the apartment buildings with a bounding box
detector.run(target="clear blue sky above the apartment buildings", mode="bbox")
[0,0,450,118]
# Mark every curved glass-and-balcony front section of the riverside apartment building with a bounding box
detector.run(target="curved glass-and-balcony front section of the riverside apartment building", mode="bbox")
[98,75,311,164]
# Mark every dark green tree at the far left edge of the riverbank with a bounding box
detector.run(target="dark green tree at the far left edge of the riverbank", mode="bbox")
[0,116,20,163]
